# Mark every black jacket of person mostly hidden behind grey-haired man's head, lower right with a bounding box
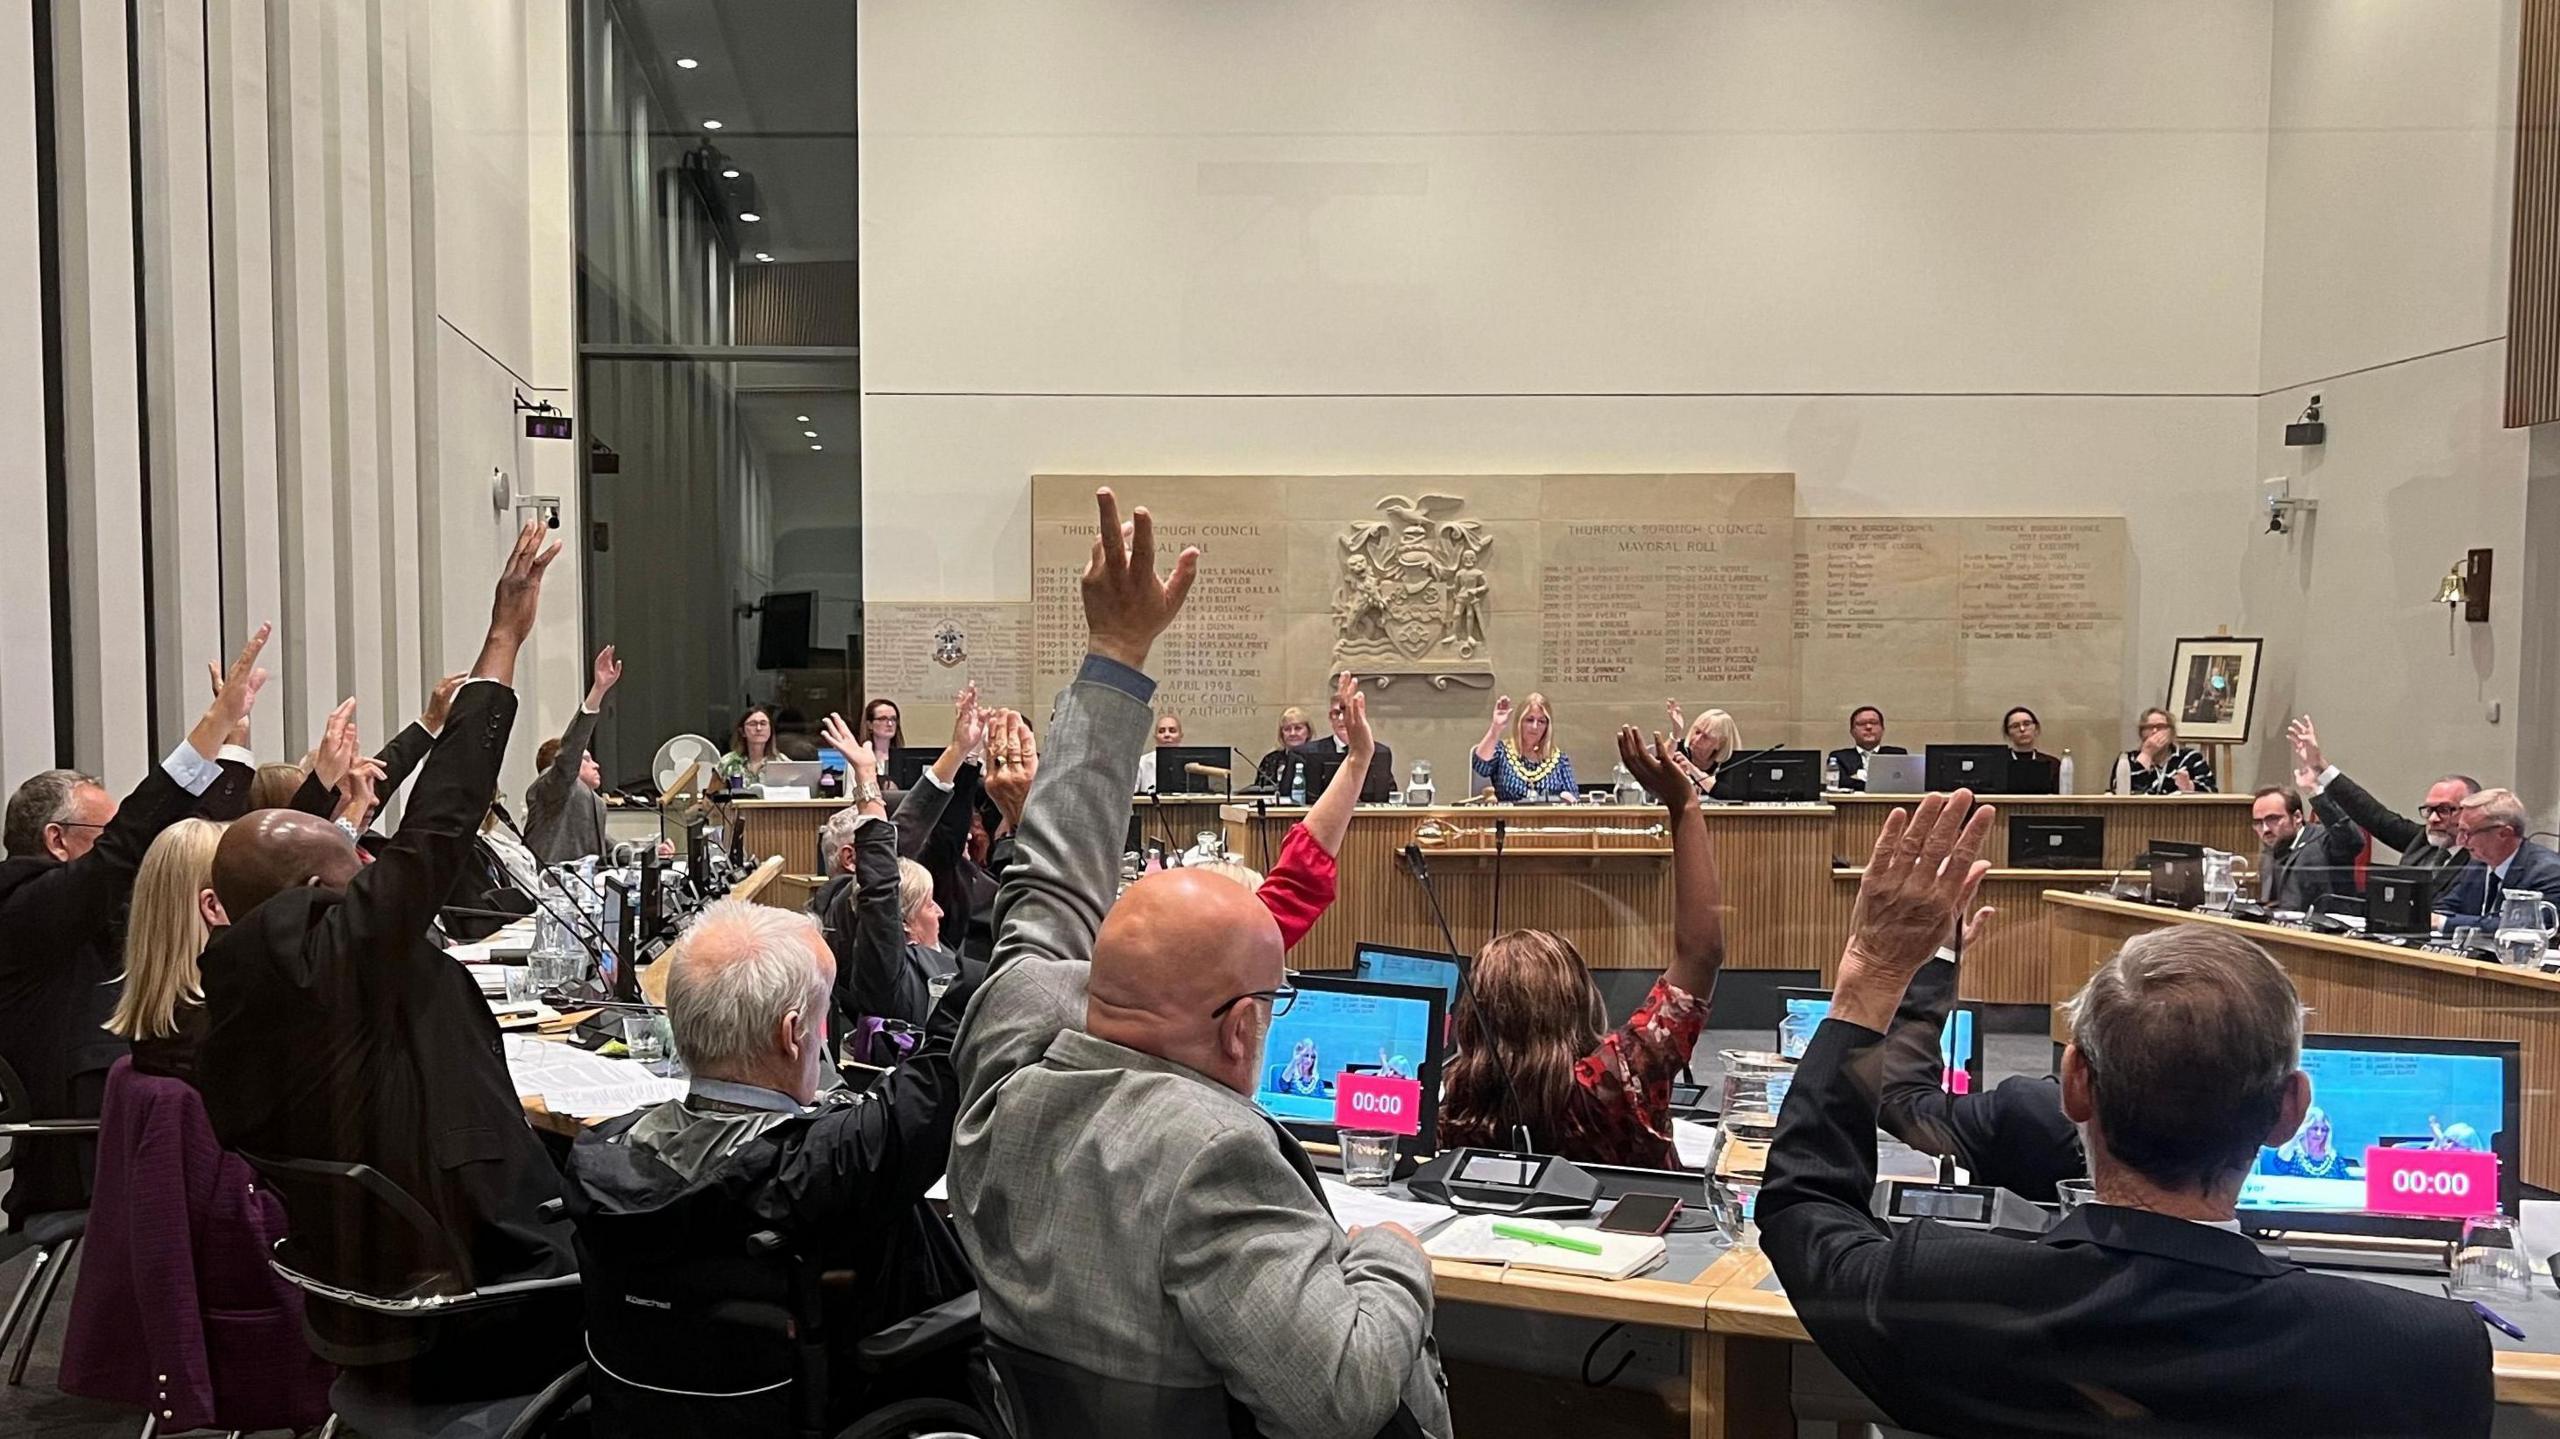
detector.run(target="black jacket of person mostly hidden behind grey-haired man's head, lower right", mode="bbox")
[1876,960,2089,1203]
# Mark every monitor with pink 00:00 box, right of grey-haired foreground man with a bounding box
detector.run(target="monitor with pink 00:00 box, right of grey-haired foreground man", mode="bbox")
[2240,1034,2524,1239]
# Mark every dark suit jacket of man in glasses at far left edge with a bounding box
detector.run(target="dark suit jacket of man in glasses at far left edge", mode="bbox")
[0,763,197,1221]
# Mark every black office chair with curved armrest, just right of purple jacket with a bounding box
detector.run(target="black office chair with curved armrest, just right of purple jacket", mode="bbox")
[241,1152,579,1439]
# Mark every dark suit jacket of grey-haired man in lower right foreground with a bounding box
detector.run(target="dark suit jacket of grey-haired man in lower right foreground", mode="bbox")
[1759,1019,2491,1439]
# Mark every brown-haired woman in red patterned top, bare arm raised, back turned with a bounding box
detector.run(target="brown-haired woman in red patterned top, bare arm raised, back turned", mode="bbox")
[1439,727,1725,1170]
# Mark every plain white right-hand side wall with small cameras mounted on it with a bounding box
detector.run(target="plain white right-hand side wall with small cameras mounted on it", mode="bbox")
[2245,0,2529,809]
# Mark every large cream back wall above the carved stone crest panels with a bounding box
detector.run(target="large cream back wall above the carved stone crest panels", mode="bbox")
[863,0,2271,773]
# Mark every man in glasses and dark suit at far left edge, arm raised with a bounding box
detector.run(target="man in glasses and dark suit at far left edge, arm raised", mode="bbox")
[0,625,266,1226]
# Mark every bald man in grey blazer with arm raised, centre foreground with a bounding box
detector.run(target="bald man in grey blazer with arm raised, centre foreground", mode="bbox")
[950,492,1449,1439]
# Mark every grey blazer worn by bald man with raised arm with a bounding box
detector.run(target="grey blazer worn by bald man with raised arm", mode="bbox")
[950,661,1449,1439]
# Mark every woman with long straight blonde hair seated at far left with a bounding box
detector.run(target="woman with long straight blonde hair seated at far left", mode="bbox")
[108,819,230,1083]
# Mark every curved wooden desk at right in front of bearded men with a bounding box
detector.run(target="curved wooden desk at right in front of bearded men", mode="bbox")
[2045,891,2560,1188]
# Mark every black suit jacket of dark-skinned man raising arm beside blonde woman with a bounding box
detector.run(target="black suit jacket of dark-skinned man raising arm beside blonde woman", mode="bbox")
[197,681,571,1283]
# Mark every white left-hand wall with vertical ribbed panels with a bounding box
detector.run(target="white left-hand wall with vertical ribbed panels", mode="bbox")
[0,0,584,786]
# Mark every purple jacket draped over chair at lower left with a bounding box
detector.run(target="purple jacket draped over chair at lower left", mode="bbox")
[61,1060,333,1431]
